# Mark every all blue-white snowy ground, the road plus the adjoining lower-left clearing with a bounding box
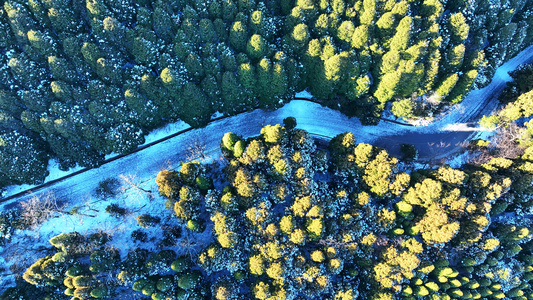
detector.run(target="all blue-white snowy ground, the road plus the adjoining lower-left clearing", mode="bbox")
[0,46,533,292]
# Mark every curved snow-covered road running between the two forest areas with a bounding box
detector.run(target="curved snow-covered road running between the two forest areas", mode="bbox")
[0,46,533,209]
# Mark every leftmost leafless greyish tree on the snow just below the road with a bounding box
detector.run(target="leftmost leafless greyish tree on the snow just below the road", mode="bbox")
[20,192,65,229]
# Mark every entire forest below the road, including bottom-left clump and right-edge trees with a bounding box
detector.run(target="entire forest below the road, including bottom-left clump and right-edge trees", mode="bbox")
[0,59,533,300]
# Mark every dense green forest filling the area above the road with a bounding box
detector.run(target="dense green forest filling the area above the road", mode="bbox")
[0,0,533,187]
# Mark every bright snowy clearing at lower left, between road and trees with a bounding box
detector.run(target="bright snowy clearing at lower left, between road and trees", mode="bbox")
[0,168,212,287]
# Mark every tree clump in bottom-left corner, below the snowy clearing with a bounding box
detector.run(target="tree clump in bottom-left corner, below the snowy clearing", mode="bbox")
[0,232,209,300]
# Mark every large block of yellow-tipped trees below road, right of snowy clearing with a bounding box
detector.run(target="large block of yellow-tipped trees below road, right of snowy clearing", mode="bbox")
[152,119,533,299]
